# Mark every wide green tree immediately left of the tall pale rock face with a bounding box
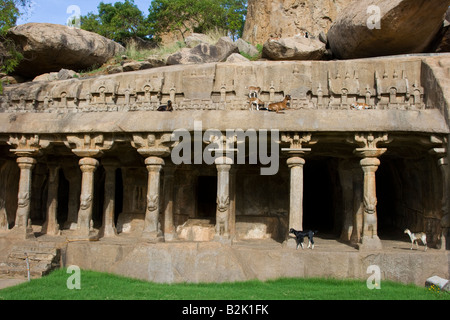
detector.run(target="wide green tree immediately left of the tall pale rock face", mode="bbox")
[148,0,247,39]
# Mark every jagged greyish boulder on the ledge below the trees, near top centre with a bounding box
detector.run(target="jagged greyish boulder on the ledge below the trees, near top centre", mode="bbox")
[167,37,239,65]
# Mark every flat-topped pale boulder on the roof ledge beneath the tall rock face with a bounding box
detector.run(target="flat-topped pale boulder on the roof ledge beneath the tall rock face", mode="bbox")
[263,37,327,60]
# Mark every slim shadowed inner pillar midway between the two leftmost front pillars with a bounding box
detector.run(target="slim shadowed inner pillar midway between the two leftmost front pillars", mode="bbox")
[42,164,60,236]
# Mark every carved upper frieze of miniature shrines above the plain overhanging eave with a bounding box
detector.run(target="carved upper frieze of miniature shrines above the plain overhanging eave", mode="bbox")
[0,59,430,114]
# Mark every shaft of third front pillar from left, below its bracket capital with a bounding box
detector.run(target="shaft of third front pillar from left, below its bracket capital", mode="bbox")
[142,157,164,241]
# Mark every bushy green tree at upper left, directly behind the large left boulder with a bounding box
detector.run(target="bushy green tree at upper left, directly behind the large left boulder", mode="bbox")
[81,0,150,44]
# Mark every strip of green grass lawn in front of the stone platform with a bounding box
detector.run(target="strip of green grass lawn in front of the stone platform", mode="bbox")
[0,269,450,300]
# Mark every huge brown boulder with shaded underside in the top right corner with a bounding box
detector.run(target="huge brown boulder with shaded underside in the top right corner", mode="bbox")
[328,0,450,59]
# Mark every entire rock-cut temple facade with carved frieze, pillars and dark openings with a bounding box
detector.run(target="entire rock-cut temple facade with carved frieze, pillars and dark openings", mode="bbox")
[0,55,450,250]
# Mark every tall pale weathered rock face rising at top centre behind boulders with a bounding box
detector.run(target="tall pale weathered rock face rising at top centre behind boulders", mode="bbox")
[242,0,350,44]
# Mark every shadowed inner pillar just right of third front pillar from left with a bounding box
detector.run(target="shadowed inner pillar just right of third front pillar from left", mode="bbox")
[163,165,177,241]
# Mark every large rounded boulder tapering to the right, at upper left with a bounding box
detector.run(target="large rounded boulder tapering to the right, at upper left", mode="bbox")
[7,23,125,78]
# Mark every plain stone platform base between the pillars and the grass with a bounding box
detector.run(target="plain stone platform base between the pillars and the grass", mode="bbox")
[0,230,450,286]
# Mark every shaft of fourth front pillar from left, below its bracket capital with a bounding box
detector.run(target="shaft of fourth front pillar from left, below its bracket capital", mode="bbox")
[214,157,233,240]
